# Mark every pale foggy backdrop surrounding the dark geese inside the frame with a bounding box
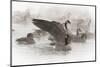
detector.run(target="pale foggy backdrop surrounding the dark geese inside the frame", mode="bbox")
[12,2,95,65]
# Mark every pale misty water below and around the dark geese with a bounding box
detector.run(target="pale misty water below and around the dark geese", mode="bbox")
[12,23,95,65]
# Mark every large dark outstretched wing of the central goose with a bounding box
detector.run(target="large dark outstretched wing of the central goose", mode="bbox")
[33,19,65,42]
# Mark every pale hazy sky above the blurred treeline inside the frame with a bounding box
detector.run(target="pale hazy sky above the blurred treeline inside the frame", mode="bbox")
[12,2,95,17]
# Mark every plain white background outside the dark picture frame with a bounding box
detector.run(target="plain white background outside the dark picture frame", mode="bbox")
[0,0,100,67]
